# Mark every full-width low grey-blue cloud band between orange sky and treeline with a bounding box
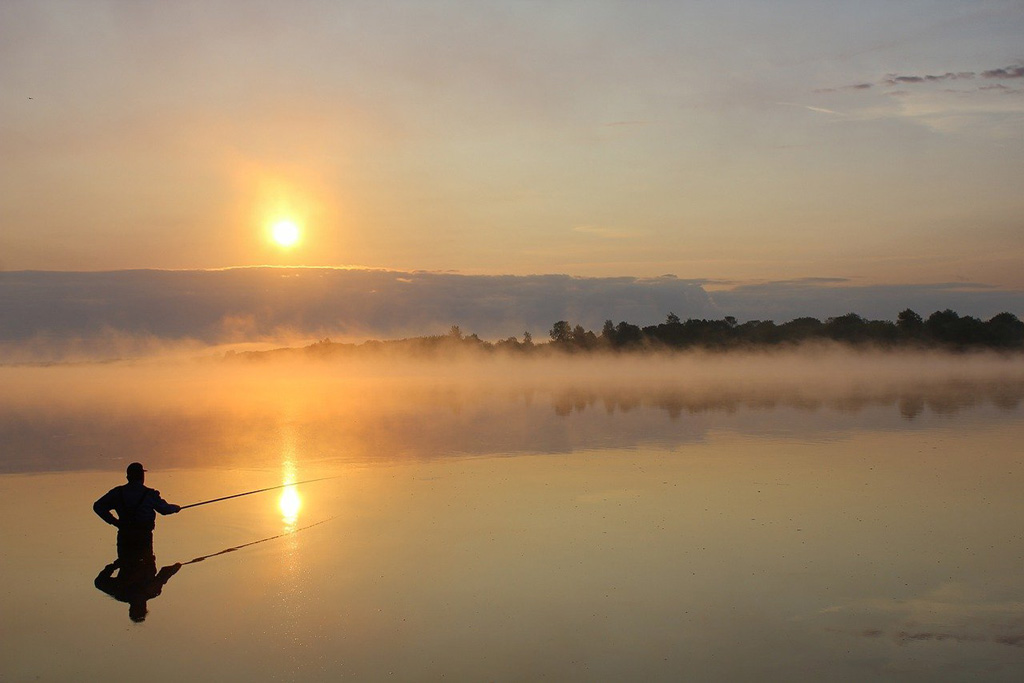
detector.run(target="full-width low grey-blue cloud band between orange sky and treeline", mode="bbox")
[0,267,1024,362]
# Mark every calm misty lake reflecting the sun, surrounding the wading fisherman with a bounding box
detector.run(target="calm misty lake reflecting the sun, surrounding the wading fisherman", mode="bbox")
[0,351,1024,681]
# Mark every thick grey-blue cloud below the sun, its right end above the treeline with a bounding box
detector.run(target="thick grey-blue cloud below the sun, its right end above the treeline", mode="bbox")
[0,267,716,356]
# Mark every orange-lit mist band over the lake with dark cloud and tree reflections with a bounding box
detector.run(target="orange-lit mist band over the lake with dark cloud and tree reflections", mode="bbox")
[0,347,1024,471]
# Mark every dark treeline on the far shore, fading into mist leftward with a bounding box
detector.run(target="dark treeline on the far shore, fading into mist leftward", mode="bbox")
[227,308,1024,359]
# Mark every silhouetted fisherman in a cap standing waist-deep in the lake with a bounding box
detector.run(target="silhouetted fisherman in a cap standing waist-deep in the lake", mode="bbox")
[92,463,181,557]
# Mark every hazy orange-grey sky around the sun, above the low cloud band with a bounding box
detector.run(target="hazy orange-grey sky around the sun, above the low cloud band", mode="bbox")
[0,0,1024,288]
